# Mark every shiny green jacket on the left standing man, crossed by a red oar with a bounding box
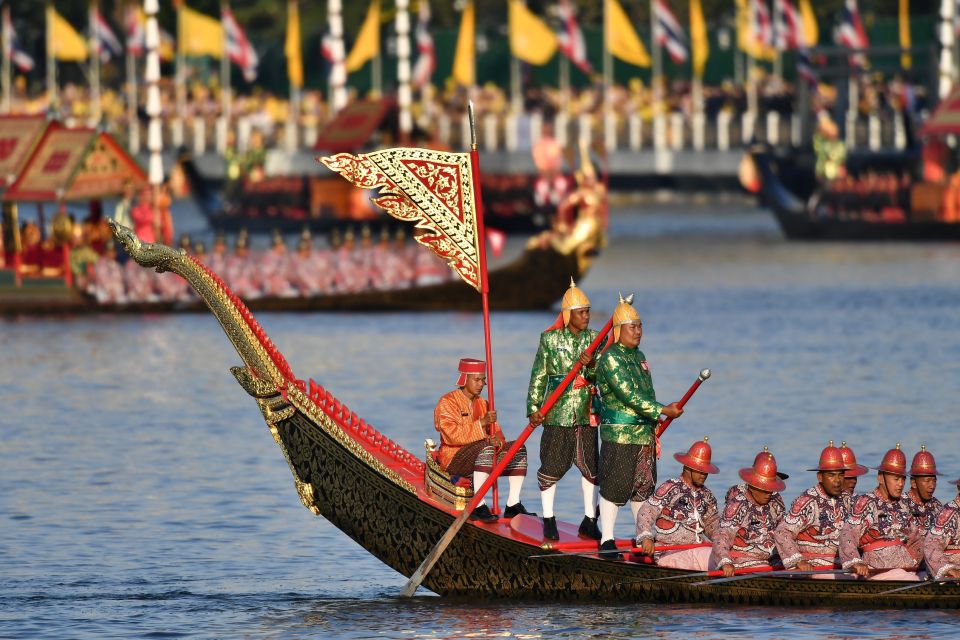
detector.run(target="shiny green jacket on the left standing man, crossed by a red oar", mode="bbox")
[527,327,597,427]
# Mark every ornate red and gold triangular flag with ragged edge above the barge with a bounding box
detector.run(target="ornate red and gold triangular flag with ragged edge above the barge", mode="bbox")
[318,147,482,291]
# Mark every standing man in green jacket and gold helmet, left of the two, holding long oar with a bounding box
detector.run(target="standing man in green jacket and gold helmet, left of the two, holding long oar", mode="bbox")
[527,278,600,540]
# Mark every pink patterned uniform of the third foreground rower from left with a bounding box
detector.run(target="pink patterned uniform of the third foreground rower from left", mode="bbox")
[773,484,847,569]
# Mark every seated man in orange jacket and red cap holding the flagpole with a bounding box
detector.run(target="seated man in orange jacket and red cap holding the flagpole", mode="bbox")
[433,358,529,522]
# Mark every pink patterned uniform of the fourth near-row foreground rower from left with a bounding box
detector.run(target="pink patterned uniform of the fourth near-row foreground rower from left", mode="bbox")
[840,489,920,580]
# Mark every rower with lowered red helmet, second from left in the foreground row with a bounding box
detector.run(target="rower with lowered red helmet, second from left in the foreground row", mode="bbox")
[710,451,786,577]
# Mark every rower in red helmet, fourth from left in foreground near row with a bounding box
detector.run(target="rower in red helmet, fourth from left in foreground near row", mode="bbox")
[840,443,923,580]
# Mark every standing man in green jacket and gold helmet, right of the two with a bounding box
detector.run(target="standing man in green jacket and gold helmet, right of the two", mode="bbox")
[596,298,683,551]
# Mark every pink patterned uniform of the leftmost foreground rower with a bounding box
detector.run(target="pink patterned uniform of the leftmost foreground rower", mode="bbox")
[637,478,720,571]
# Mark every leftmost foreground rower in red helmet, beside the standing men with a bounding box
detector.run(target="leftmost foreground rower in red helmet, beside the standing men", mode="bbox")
[637,438,720,571]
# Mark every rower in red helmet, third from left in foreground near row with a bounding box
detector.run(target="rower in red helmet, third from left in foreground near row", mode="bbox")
[773,440,847,579]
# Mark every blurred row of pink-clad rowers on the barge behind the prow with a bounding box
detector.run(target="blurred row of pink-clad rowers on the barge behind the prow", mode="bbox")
[84,227,453,304]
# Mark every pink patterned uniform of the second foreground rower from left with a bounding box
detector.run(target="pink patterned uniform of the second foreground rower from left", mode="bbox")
[710,484,784,569]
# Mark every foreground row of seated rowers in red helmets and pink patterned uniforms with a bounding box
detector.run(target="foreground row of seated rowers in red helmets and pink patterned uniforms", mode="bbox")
[624,438,960,581]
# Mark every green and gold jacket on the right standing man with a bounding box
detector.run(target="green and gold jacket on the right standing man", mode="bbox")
[596,342,663,444]
